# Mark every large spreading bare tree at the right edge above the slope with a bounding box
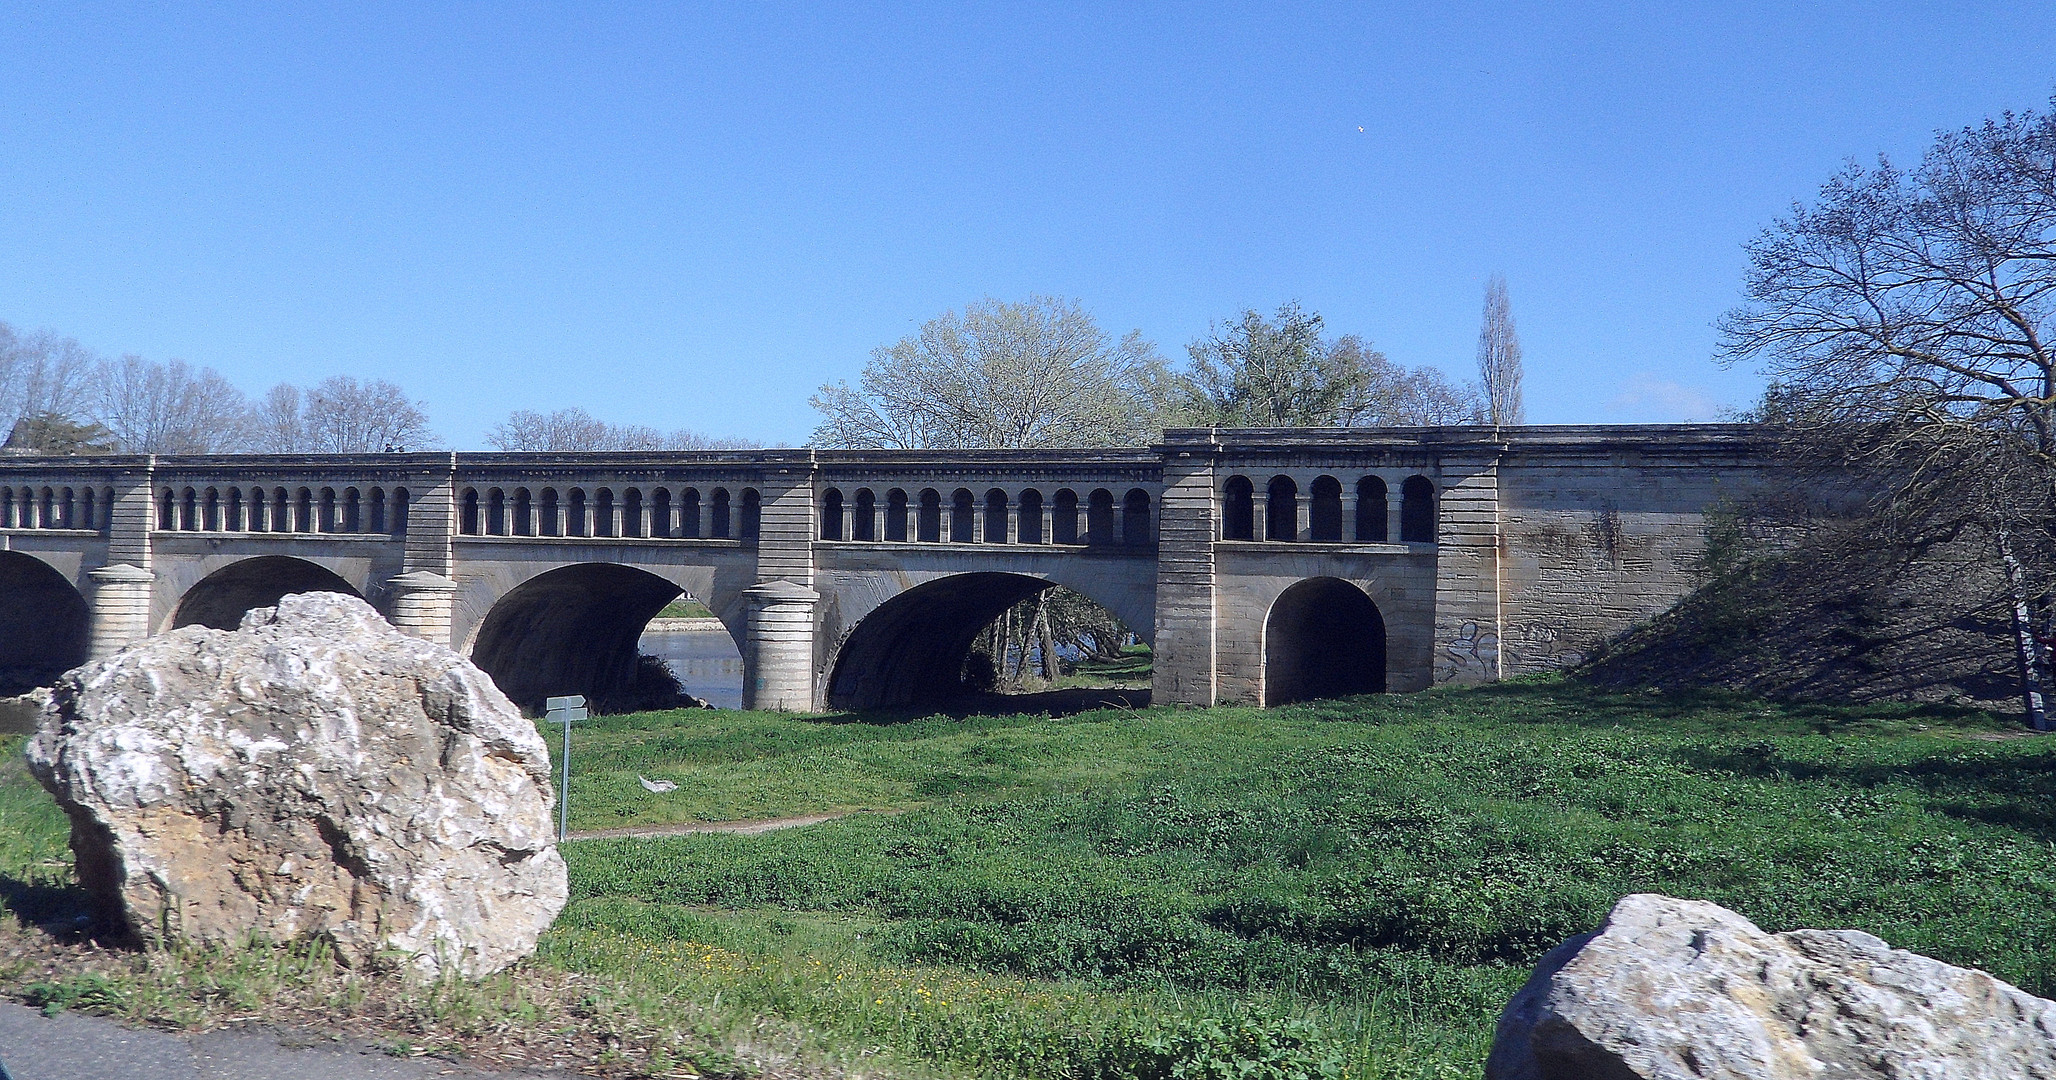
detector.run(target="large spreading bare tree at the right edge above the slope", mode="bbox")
[1723,99,2056,728]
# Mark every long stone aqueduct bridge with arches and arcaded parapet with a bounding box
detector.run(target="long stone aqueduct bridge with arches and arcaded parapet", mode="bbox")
[0,424,1760,710]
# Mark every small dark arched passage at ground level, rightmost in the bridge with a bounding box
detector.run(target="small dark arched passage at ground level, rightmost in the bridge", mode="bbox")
[1264,578,1386,706]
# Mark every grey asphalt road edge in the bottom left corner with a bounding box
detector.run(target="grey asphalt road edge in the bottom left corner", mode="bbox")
[0,1004,570,1080]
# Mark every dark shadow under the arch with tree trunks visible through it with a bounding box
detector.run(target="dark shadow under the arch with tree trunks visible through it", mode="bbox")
[829,572,1134,710]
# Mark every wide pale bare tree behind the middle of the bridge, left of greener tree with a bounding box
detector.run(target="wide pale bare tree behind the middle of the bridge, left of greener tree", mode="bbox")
[812,296,1168,448]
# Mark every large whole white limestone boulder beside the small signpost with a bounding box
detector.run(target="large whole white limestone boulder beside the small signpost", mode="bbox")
[29,592,567,977]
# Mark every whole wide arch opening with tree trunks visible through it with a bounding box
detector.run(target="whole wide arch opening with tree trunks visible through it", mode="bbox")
[829,572,1149,712]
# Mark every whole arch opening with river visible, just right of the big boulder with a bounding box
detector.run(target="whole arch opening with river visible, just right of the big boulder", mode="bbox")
[471,564,742,712]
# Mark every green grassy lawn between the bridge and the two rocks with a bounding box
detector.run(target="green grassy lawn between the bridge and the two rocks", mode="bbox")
[0,681,2056,1078]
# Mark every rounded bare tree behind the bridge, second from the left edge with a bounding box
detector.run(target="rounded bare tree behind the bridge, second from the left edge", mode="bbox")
[90,356,249,455]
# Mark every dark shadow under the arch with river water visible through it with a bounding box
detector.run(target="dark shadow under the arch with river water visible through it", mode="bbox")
[471,562,711,712]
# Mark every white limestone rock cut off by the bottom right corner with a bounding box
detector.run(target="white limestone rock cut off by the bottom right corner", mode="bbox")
[1484,893,2056,1080]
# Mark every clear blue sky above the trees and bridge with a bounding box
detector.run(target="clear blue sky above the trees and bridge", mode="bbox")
[0,0,2056,448]
